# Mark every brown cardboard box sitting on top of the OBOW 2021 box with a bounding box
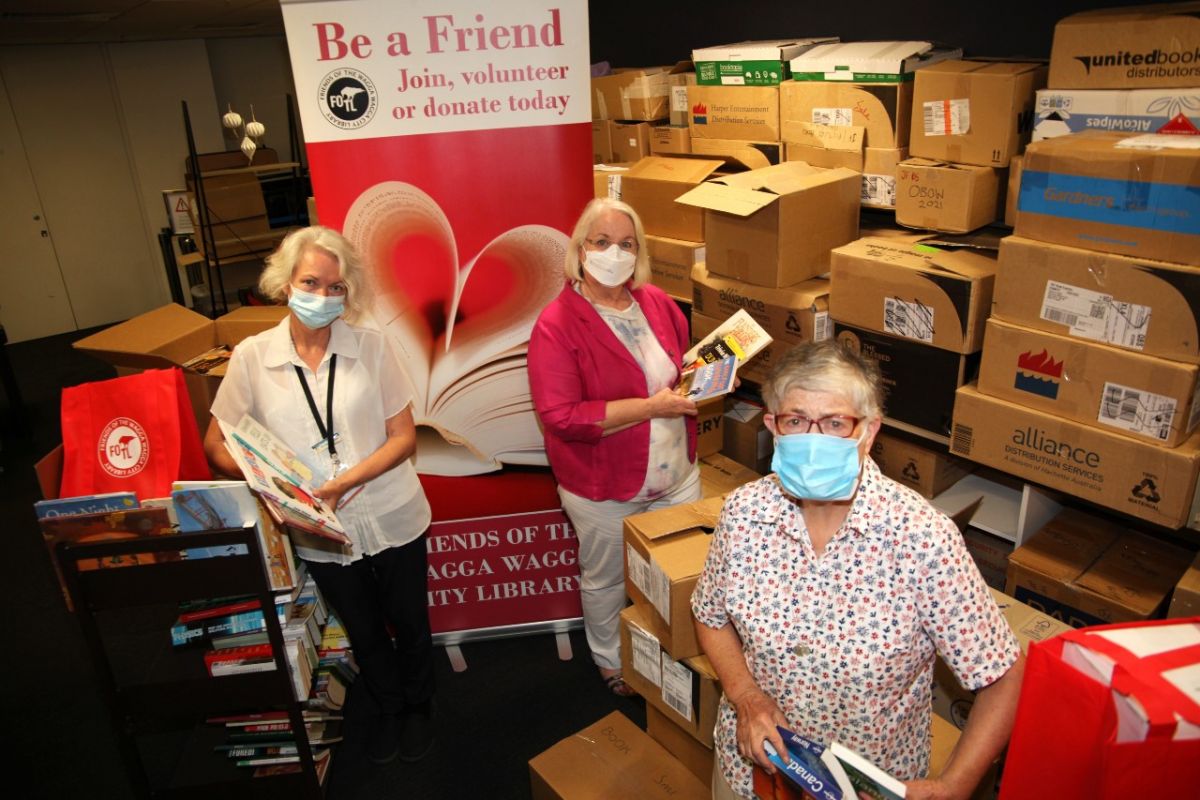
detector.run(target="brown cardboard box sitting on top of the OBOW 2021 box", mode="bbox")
[908,61,1046,168]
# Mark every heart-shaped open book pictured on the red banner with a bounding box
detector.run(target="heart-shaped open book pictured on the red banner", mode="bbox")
[343,181,568,475]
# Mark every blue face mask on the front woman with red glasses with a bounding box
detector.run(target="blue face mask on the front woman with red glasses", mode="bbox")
[770,433,862,500]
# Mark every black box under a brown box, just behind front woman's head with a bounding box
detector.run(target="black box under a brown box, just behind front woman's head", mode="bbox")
[833,323,979,437]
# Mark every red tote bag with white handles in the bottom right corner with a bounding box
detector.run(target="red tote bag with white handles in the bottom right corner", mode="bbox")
[1000,618,1200,800]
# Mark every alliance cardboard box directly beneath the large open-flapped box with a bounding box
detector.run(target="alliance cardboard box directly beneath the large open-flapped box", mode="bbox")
[691,264,833,383]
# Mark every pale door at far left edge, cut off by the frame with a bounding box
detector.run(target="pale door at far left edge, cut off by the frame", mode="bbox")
[0,70,77,342]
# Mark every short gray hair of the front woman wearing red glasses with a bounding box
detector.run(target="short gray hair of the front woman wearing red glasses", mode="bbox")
[762,339,883,420]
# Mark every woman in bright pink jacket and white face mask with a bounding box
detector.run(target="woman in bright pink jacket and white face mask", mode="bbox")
[529,198,700,697]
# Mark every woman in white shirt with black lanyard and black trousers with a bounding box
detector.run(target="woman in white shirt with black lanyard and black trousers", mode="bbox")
[204,227,433,764]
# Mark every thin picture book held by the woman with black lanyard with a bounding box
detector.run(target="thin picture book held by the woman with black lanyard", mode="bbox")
[218,414,350,545]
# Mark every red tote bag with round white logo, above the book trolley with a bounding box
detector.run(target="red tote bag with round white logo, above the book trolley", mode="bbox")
[60,367,211,500]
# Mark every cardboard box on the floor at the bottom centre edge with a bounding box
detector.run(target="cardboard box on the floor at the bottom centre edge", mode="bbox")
[529,711,712,800]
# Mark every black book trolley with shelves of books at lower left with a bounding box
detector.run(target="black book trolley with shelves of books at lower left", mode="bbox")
[58,528,323,799]
